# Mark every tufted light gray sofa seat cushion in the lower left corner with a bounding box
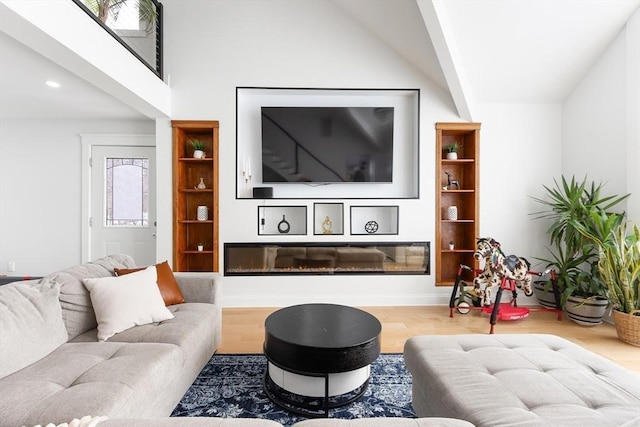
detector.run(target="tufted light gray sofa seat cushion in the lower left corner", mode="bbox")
[0,342,183,427]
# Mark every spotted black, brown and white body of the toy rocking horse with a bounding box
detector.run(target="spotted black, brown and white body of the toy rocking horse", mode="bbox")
[473,237,533,306]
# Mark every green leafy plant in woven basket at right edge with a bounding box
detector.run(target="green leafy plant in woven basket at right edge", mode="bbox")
[575,211,640,346]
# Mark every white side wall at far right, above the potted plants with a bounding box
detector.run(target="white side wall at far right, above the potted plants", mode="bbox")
[561,11,640,224]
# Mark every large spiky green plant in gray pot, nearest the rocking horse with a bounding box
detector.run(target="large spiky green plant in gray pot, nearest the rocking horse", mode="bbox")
[533,176,629,326]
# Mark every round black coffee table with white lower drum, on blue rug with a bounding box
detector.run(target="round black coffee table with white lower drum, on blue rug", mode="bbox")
[264,304,382,417]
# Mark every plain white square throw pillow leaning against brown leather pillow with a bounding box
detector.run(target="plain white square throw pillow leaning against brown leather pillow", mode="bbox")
[83,266,173,341]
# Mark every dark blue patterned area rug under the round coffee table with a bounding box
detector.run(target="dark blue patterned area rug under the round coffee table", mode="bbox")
[171,354,415,426]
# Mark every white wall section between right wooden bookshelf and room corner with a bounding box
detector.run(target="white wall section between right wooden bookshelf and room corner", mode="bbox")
[477,104,562,260]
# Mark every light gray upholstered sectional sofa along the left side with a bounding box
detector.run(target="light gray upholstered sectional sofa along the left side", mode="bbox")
[0,255,470,427]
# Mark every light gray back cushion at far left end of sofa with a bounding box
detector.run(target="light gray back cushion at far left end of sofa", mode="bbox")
[0,282,68,378]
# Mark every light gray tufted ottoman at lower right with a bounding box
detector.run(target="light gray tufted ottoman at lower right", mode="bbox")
[404,334,640,427]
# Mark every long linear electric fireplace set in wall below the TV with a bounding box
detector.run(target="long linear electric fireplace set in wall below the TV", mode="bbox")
[224,242,430,276]
